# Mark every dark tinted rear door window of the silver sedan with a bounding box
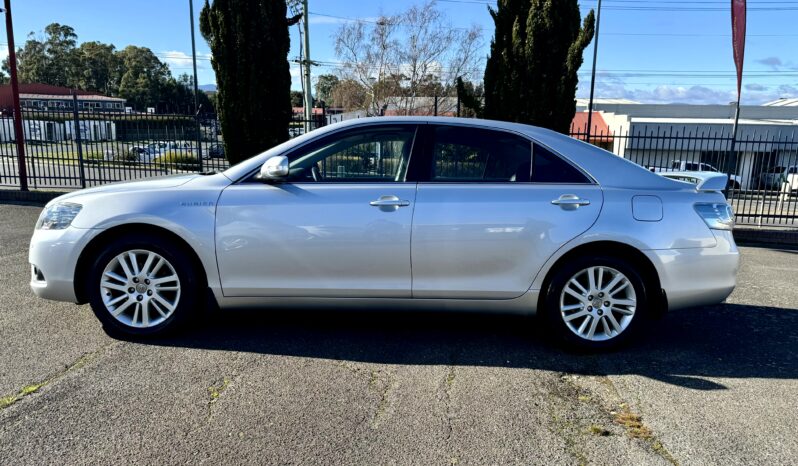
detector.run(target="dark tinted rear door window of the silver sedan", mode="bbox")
[431,126,532,182]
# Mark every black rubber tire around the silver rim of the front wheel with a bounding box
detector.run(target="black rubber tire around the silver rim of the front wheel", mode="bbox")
[86,233,205,337]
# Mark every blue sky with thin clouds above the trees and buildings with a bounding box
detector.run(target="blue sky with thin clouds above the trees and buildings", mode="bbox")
[3,0,798,104]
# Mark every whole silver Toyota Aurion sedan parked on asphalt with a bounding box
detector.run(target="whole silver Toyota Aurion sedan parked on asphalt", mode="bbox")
[29,117,739,349]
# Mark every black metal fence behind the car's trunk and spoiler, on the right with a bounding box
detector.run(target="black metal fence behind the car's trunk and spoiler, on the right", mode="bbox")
[571,126,798,228]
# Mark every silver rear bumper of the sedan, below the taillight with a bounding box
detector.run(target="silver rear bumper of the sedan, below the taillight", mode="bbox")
[643,230,740,310]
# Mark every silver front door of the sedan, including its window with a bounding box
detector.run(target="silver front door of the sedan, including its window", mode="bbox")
[216,124,416,297]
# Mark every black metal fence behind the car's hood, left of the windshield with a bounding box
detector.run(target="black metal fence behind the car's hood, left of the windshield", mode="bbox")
[0,111,324,189]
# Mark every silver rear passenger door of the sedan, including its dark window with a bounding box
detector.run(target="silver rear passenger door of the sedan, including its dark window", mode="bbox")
[411,125,602,299]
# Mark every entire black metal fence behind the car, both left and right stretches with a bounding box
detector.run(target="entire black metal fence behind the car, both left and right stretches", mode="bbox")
[0,111,798,228]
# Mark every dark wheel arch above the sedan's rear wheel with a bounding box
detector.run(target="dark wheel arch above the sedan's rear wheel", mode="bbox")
[538,241,668,315]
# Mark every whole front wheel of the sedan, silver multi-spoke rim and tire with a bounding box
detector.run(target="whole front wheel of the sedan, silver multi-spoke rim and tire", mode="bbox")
[87,235,198,336]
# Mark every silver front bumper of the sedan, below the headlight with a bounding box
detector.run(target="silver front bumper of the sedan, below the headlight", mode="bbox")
[28,226,102,303]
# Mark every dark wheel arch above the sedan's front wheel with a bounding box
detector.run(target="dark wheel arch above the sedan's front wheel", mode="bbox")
[74,223,208,304]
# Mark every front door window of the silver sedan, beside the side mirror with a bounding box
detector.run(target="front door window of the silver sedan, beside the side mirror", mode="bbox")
[289,125,416,183]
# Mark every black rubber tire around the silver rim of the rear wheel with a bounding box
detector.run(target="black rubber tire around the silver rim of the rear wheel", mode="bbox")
[541,255,652,351]
